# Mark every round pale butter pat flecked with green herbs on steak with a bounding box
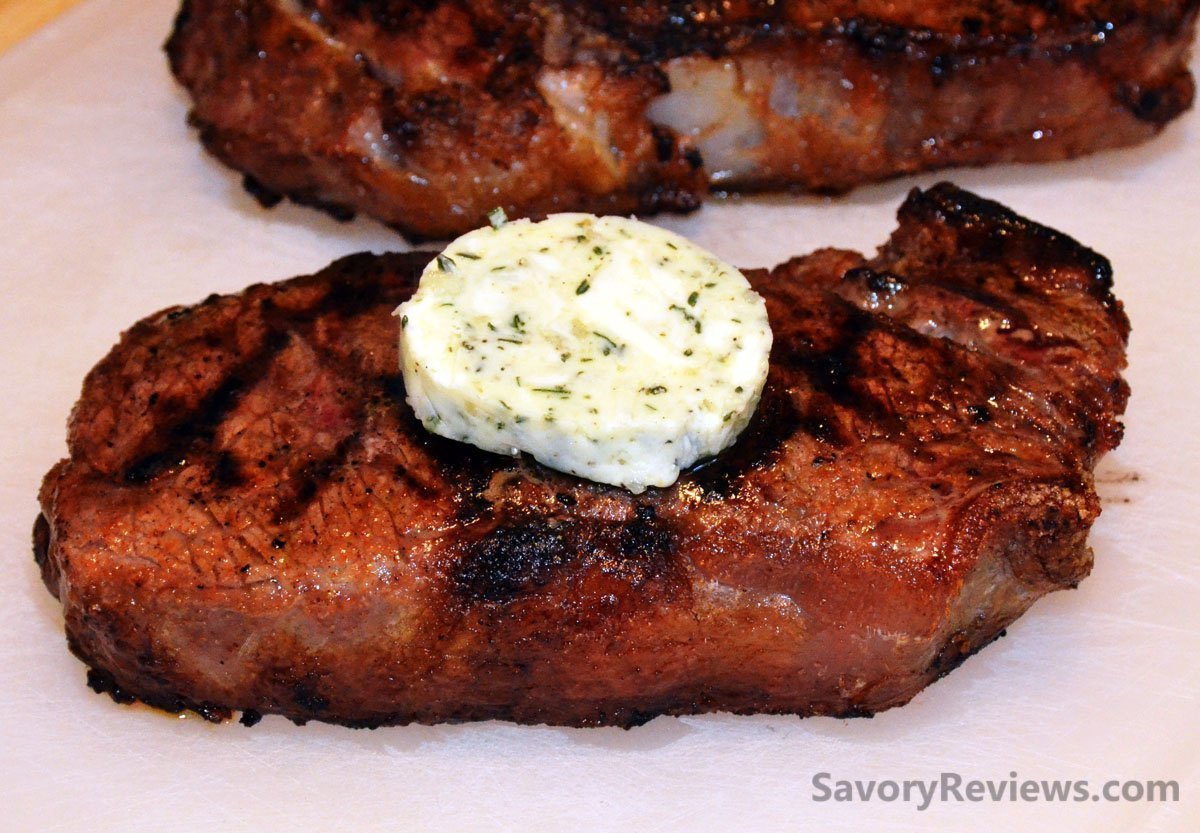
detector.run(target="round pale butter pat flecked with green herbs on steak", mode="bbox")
[396,214,772,492]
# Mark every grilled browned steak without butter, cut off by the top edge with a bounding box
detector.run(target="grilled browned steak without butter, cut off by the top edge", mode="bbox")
[167,0,1200,238]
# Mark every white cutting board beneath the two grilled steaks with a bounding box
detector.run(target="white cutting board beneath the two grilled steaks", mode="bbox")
[0,0,1200,833]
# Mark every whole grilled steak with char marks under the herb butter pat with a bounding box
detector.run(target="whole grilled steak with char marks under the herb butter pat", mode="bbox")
[35,185,1128,726]
